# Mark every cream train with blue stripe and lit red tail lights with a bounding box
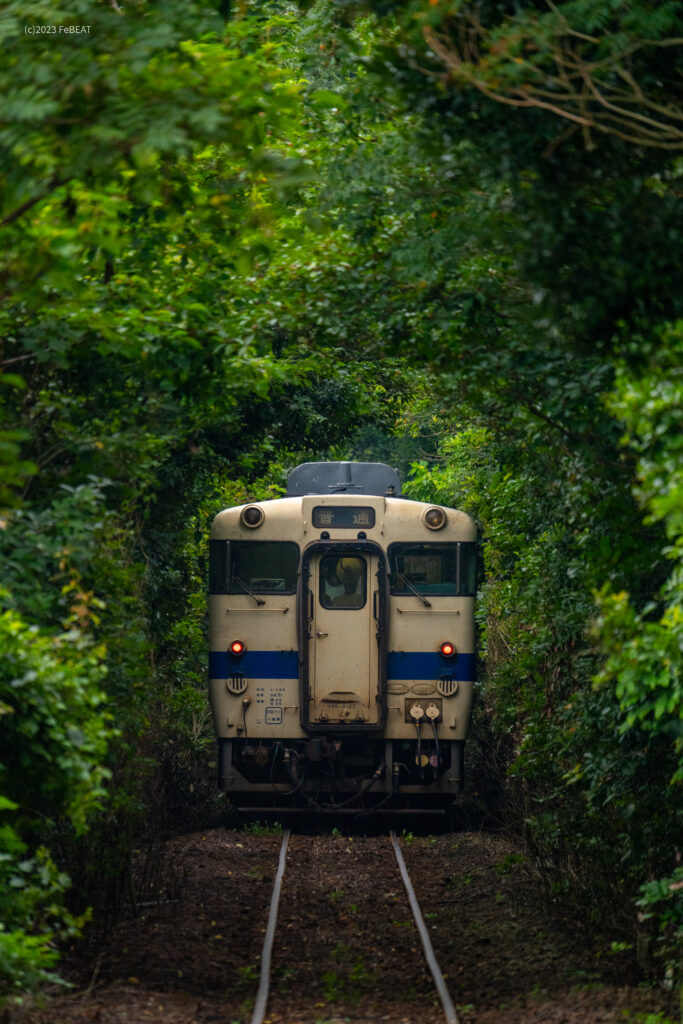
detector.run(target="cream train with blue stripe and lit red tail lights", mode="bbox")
[209,462,477,814]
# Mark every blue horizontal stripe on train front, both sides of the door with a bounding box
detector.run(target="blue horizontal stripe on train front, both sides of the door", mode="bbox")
[209,650,474,680]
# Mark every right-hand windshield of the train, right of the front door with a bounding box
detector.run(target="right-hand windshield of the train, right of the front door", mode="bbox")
[389,542,476,597]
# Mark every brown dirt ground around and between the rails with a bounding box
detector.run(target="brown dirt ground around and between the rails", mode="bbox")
[9,828,673,1024]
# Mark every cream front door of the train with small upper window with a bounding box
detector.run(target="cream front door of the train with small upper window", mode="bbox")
[307,549,383,727]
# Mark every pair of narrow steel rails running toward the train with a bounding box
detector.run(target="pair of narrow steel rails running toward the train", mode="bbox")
[251,828,459,1024]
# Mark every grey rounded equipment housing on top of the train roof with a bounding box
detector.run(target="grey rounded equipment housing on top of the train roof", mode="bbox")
[287,462,400,498]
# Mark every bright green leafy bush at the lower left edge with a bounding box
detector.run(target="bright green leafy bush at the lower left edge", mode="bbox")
[0,592,114,994]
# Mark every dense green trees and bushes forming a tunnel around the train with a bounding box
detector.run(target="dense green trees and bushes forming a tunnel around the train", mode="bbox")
[0,0,683,1007]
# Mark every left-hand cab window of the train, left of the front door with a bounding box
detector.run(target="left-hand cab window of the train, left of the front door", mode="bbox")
[209,541,299,594]
